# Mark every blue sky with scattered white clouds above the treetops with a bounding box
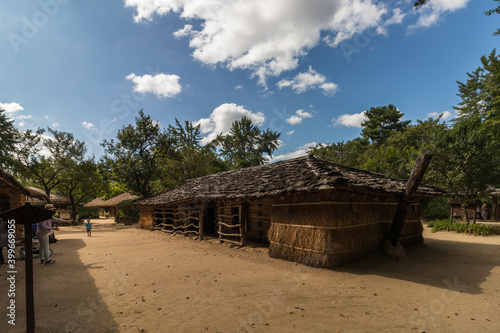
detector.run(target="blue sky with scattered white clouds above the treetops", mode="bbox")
[0,0,500,159]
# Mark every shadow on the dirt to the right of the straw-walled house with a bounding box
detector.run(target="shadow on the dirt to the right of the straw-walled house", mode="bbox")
[335,235,500,294]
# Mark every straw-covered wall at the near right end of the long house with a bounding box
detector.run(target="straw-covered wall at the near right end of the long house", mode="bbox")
[269,193,423,267]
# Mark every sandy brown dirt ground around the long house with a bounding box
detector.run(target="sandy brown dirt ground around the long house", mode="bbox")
[0,219,500,333]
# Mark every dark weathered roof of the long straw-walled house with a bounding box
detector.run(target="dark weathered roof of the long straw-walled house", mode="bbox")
[134,156,445,205]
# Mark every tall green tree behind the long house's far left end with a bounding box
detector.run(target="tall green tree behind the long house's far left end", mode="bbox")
[101,109,175,196]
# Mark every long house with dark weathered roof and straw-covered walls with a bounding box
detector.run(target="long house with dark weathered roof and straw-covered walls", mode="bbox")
[134,156,444,267]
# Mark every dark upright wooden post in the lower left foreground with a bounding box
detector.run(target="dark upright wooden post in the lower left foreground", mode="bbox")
[24,224,35,333]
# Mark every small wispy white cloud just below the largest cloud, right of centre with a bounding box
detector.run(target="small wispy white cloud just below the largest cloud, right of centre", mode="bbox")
[277,67,338,96]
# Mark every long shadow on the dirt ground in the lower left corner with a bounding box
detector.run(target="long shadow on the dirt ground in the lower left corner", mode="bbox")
[0,239,118,333]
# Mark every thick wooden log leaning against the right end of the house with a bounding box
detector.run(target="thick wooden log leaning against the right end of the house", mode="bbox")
[386,153,432,246]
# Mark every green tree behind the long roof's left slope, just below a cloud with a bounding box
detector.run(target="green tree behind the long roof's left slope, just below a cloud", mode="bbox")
[212,117,280,169]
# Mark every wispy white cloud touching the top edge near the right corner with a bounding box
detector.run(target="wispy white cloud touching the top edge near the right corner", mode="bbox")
[408,0,470,31]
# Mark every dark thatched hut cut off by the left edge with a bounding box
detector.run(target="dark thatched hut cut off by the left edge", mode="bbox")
[0,169,30,239]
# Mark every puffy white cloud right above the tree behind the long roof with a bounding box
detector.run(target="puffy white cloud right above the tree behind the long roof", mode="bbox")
[194,103,266,144]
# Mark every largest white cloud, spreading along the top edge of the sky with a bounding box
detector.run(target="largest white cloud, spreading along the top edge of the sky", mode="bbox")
[125,0,397,85]
